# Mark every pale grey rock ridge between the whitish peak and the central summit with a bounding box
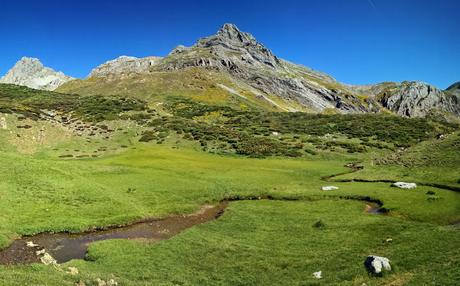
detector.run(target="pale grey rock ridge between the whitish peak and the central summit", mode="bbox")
[88,56,161,77]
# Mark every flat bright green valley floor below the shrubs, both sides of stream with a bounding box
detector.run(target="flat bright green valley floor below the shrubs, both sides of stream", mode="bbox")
[0,143,460,285]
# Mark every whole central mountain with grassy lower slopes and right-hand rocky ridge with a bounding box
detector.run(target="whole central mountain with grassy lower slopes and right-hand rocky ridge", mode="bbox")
[60,24,460,117]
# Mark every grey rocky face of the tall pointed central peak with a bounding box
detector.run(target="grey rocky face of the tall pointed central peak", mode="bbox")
[154,24,371,112]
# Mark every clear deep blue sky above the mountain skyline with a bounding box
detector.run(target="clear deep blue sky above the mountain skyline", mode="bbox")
[0,0,460,88]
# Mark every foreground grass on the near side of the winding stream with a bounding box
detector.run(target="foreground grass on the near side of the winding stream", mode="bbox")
[0,200,460,285]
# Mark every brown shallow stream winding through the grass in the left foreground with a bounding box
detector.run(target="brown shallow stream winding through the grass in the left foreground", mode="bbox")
[0,197,385,265]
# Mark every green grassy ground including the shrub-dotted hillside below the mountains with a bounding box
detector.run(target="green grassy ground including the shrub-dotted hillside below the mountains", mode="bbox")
[0,86,460,286]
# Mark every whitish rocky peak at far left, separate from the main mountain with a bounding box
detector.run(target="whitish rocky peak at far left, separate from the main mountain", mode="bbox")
[0,57,74,90]
